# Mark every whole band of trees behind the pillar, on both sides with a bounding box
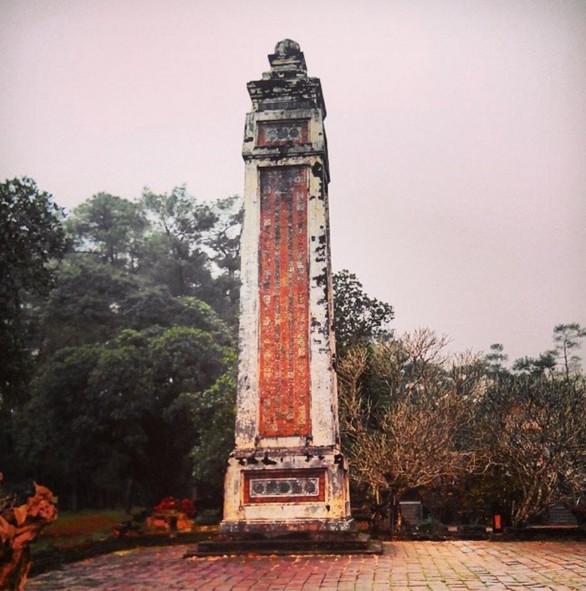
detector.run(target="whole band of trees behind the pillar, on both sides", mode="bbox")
[0,173,586,526]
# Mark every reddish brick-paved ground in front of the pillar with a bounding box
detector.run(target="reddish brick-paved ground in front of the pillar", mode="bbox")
[27,541,586,591]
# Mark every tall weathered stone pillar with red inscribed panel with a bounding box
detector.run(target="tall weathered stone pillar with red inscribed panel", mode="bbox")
[221,39,351,533]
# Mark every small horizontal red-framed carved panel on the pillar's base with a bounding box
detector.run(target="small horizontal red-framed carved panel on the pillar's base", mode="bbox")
[244,470,325,503]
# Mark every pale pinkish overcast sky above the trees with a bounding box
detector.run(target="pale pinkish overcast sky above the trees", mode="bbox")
[0,0,586,359]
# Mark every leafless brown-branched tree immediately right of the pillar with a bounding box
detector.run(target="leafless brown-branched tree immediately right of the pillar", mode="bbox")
[338,330,484,512]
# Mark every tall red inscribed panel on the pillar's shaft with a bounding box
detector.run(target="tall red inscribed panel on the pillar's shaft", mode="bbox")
[259,166,311,437]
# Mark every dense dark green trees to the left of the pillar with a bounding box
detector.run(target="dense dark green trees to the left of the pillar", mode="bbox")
[0,180,240,508]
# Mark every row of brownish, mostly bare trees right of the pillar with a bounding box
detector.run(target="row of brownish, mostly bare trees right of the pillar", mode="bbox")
[338,324,586,526]
